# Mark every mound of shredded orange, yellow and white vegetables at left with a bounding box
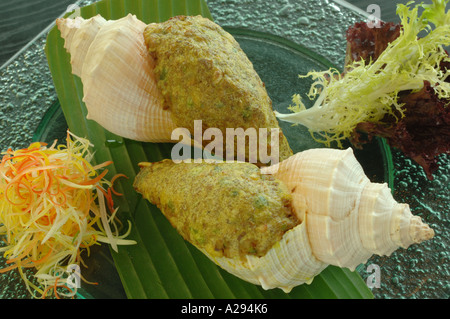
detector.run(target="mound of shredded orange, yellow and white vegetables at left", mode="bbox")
[0,132,135,297]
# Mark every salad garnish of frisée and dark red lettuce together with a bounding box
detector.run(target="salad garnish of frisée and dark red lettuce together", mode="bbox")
[277,0,450,179]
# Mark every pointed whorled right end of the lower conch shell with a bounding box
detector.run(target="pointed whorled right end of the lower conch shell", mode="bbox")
[263,148,434,270]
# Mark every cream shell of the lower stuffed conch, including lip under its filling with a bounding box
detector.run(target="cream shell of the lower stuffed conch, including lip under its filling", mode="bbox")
[135,149,434,292]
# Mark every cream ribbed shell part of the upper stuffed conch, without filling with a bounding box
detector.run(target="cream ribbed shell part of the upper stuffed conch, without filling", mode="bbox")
[56,14,176,142]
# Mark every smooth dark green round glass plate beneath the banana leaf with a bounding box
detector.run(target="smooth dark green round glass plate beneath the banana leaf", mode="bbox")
[33,28,392,298]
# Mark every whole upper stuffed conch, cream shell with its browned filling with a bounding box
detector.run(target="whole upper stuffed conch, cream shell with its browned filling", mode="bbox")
[56,14,292,159]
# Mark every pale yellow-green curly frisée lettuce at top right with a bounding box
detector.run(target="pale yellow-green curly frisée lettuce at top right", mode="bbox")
[276,0,450,147]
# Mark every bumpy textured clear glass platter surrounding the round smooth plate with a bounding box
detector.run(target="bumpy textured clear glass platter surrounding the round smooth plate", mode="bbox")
[0,0,450,298]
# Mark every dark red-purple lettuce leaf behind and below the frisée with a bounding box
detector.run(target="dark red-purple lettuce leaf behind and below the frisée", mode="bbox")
[346,22,450,180]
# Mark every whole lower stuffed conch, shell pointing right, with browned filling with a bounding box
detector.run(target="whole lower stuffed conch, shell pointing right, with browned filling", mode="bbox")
[134,148,434,292]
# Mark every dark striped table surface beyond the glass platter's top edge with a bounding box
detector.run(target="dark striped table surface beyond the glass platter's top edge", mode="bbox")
[0,0,430,66]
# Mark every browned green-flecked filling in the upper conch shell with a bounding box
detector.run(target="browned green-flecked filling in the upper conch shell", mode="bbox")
[144,16,292,161]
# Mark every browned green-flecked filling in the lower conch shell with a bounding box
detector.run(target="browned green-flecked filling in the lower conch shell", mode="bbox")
[134,160,300,258]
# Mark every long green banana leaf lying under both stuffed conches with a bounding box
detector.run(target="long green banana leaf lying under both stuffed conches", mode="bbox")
[45,0,372,298]
